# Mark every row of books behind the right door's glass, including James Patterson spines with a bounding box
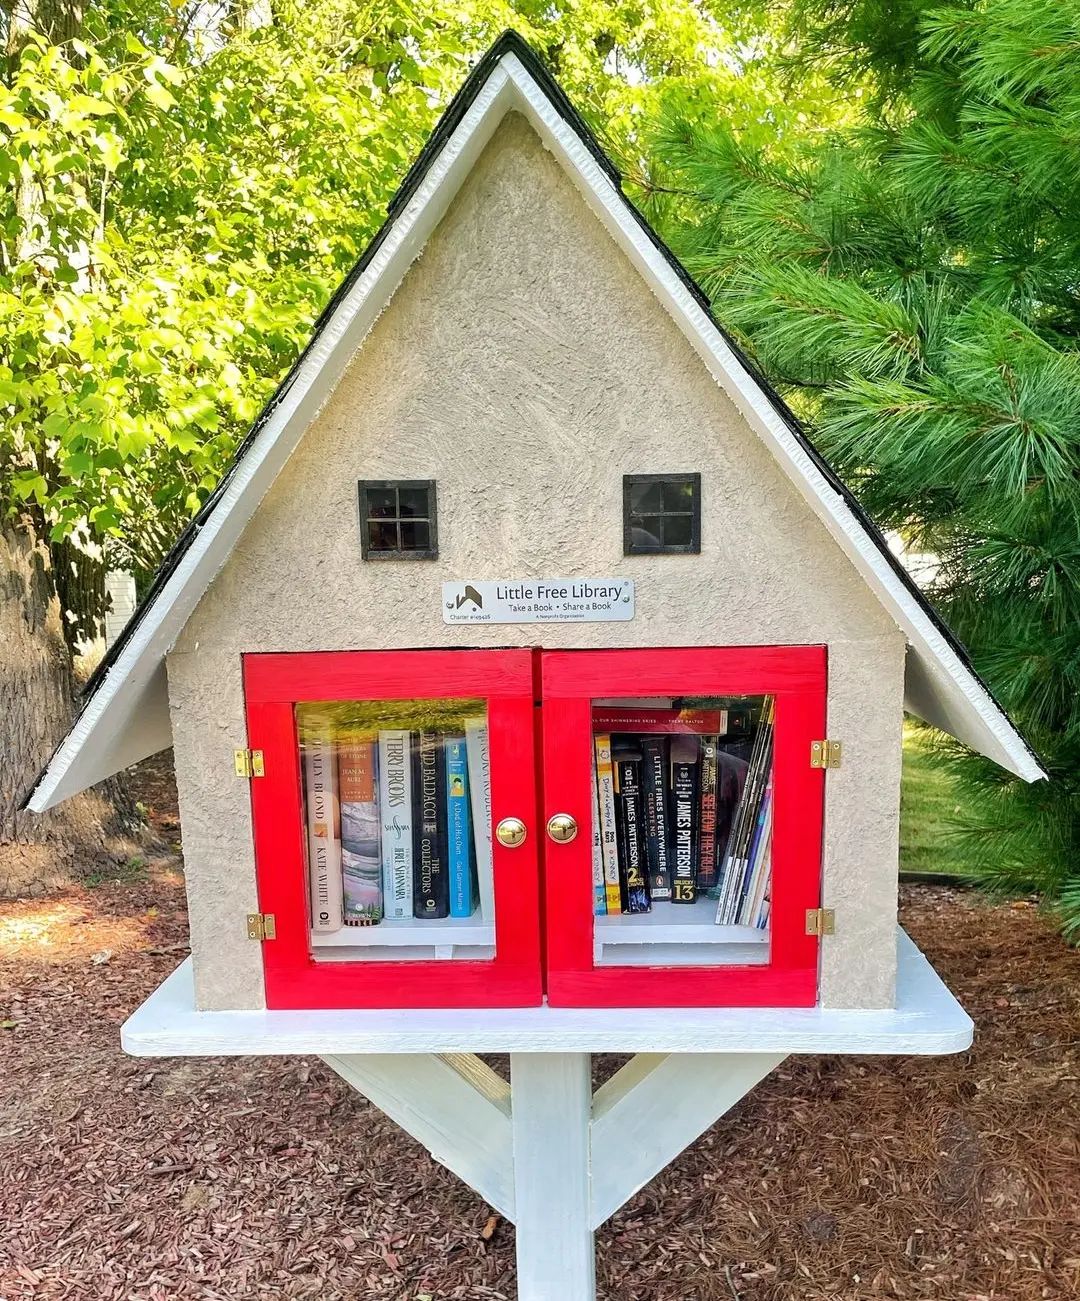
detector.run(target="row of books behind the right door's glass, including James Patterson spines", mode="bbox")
[592,696,774,929]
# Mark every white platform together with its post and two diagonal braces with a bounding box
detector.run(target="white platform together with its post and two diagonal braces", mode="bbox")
[121,932,972,1301]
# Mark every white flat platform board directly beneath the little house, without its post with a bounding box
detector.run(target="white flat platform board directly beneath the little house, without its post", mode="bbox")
[121,932,972,1056]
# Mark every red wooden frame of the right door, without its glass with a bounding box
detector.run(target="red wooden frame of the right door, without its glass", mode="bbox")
[541,647,826,1007]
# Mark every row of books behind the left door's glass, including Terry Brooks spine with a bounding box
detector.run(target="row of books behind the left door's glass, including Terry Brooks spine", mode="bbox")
[303,717,494,932]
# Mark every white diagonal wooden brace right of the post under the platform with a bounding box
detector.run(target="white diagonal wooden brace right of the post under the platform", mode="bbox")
[589,1053,786,1228]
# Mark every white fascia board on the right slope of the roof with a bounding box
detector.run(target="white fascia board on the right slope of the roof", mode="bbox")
[502,55,1046,782]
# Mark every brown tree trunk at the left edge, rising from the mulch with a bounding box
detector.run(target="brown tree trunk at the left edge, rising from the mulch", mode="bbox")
[0,523,139,898]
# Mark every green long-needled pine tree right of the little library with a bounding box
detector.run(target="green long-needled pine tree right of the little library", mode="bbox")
[658,0,1080,932]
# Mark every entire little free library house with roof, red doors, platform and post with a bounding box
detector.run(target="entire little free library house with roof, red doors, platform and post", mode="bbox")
[29,34,1045,1301]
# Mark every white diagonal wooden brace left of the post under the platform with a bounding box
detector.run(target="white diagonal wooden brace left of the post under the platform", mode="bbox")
[323,1053,515,1222]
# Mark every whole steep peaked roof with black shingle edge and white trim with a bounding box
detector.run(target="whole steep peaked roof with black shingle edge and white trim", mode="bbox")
[26,31,1046,812]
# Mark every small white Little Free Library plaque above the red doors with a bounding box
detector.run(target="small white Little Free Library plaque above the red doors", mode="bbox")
[442,578,634,623]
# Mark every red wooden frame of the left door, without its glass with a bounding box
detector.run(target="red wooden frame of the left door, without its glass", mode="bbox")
[243,649,543,1008]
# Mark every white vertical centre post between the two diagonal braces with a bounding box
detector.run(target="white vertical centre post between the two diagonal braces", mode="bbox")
[510,1053,596,1301]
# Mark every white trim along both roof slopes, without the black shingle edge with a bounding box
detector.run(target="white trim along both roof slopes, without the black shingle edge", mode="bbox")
[27,52,1046,812]
